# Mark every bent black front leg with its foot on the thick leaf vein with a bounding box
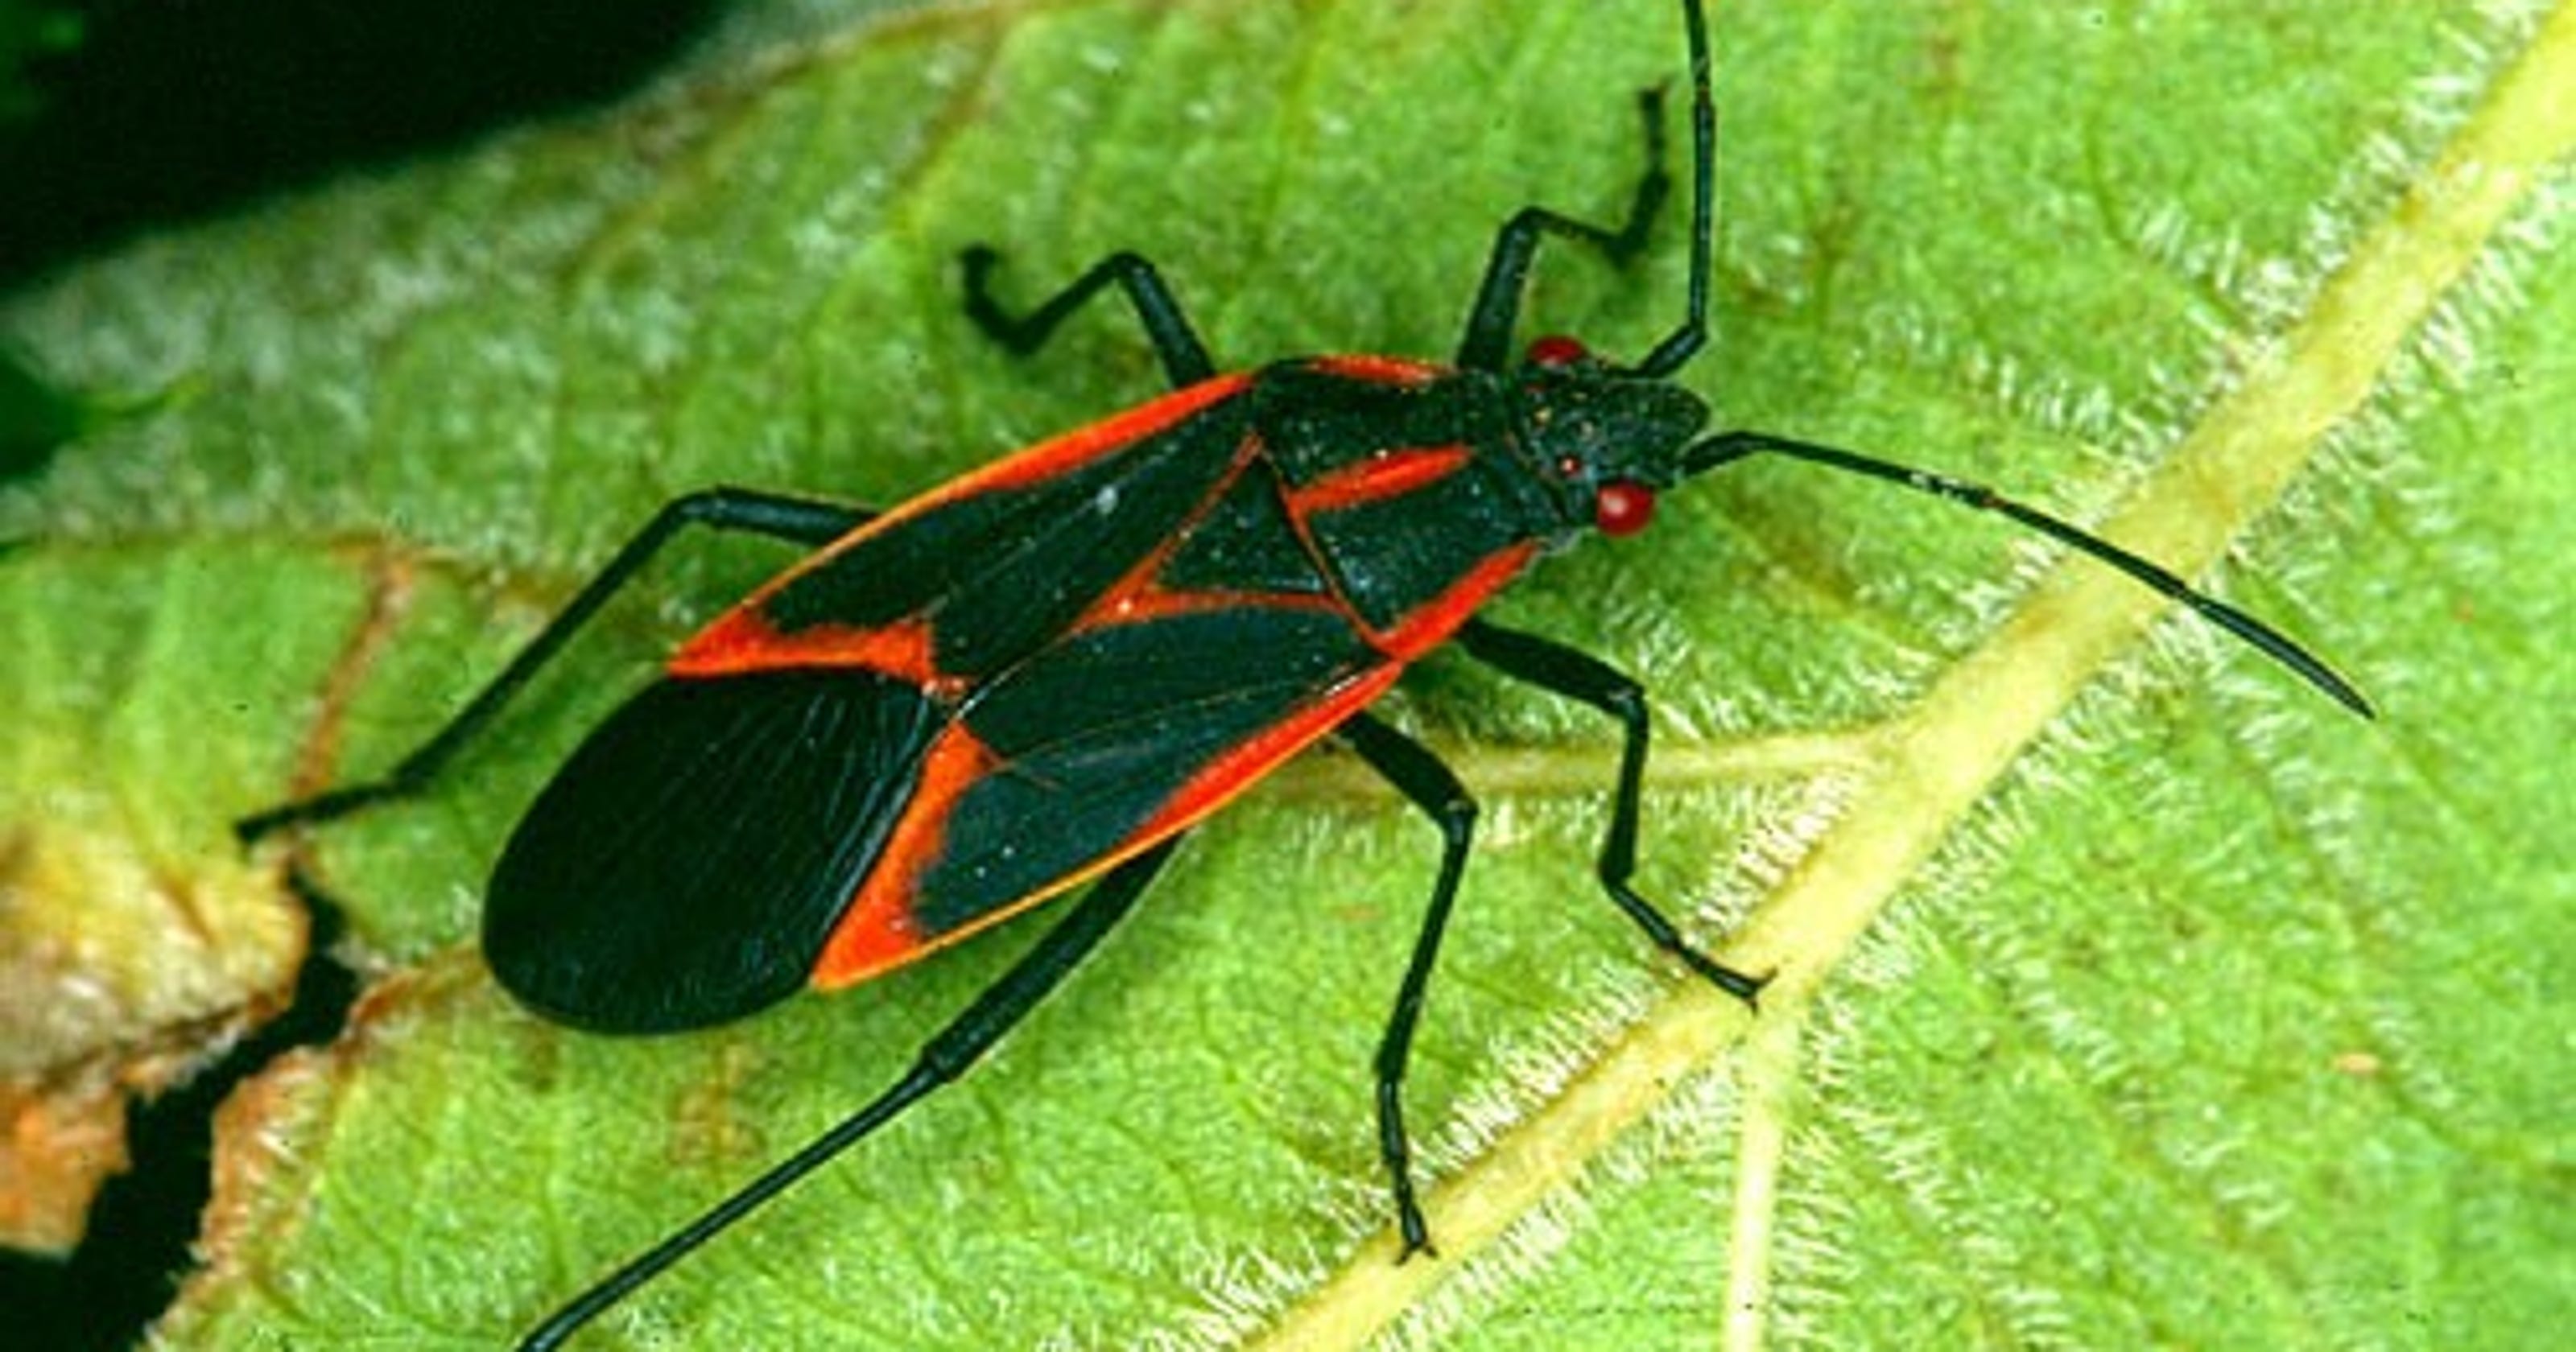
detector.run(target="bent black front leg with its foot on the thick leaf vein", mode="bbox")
[1458,620,1767,1004]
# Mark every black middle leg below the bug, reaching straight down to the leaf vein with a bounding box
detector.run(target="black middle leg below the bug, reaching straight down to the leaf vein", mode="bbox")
[1337,713,1476,1262]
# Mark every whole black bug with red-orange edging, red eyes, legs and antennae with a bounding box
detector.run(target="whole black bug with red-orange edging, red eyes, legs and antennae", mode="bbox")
[237,0,2370,1347]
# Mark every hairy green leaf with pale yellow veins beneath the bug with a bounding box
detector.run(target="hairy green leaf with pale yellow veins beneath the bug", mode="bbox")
[0,0,2576,1347]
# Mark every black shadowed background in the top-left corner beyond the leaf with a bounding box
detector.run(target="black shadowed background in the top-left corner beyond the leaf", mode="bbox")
[0,0,724,294]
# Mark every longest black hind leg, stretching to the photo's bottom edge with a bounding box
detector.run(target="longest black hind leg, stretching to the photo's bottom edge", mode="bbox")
[518,837,1180,1352]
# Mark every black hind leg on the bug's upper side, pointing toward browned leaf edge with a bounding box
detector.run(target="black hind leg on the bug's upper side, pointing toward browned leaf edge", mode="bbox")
[232,487,876,845]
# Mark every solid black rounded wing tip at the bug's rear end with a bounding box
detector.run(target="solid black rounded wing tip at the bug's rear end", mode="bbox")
[485,670,943,1033]
